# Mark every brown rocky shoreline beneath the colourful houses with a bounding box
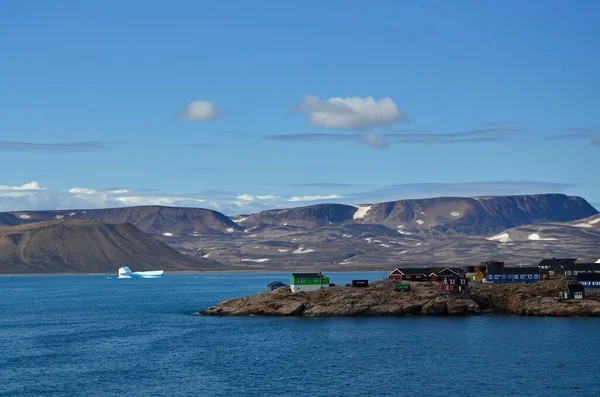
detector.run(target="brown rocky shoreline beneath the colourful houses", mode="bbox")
[199,280,600,317]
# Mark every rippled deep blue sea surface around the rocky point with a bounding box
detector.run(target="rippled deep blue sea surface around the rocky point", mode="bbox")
[0,273,600,396]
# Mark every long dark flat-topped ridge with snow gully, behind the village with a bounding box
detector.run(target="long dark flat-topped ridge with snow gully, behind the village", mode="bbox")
[236,194,598,237]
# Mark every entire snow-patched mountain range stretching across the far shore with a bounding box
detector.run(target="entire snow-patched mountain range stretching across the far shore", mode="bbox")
[0,194,600,273]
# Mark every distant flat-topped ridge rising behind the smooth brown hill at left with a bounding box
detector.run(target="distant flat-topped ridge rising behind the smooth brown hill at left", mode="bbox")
[0,206,241,237]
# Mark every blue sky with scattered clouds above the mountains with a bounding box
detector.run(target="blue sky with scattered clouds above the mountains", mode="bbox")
[0,0,600,214]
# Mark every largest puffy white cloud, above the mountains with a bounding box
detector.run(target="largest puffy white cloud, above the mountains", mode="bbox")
[290,95,408,130]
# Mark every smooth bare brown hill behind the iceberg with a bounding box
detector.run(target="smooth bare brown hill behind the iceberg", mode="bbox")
[0,219,223,274]
